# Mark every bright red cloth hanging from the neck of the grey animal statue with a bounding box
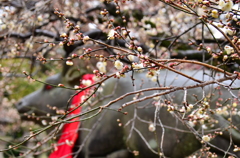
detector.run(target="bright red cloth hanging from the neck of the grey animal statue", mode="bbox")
[49,74,94,158]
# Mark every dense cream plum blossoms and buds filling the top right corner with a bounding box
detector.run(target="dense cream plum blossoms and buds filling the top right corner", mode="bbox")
[169,0,240,63]
